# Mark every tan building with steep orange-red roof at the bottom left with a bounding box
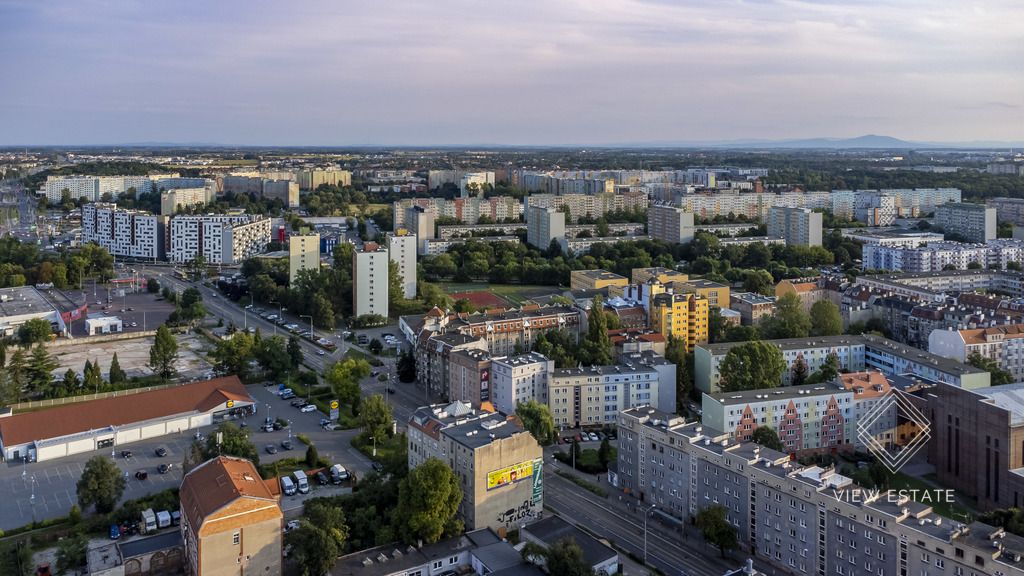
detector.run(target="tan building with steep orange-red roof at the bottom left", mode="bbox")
[180,456,285,576]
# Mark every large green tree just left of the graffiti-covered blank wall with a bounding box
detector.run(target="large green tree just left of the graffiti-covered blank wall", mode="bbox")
[394,458,462,544]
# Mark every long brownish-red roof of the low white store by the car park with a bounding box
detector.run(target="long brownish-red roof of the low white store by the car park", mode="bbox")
[0,376,253,446]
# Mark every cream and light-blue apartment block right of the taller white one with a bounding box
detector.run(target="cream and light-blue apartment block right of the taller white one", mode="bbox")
[548,364,659,428]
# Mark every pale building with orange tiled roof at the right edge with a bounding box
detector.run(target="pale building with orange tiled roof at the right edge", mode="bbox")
[928,324,1024,381]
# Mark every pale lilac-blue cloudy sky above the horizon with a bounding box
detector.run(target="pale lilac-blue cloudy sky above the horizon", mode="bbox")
[0,0,1024,146]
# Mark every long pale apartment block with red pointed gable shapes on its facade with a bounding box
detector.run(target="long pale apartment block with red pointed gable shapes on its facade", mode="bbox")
[700,371,897,455]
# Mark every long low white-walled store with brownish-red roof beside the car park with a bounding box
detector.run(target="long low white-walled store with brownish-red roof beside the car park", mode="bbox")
[0,376,255,461]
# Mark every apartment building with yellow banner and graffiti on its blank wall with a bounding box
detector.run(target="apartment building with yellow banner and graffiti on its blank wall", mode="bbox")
[408,402,544,534]
